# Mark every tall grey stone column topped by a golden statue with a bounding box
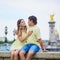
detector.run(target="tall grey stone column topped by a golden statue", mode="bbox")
[48,14,56,46]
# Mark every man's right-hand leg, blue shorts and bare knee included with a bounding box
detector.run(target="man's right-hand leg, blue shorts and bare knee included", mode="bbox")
[26,44,40,60]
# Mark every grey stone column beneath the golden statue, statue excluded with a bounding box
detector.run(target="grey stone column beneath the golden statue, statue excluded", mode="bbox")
[48,22,56,45]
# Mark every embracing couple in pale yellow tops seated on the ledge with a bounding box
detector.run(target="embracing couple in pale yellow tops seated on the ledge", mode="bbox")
[11,16,44,60]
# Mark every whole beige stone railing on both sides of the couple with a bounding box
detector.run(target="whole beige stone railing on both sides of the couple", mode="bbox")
[0,51,60,60]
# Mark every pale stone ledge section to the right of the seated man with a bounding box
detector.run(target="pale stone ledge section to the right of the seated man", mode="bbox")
[34,52,60,59]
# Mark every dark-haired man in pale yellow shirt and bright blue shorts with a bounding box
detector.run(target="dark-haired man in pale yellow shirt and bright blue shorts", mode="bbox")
[19,16,44,60]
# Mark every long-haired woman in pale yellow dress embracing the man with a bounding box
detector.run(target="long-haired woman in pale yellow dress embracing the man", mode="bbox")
[11,19,32,60]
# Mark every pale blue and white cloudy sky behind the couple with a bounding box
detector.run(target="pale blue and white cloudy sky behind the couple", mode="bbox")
[0,0,60,40]
